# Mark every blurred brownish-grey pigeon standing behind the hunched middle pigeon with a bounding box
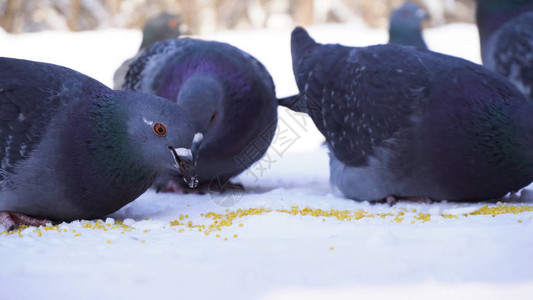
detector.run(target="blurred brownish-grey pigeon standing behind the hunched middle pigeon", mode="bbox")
[113,12,189,89]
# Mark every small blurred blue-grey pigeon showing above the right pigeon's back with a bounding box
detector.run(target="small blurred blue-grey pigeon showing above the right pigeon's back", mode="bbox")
[389,2,429,50]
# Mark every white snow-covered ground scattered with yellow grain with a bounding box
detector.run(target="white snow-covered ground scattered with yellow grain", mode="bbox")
[0,24,533,299]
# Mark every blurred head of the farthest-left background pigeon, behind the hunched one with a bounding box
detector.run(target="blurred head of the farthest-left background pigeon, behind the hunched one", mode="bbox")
[140,13,188,50]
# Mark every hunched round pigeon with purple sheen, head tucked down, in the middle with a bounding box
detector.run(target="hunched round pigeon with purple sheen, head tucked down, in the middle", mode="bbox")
[123,38,278,191]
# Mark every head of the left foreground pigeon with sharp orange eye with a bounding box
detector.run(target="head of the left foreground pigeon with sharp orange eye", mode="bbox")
[117,91,198,188]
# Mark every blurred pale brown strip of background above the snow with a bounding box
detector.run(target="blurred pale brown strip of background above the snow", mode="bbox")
[0,0,474,34]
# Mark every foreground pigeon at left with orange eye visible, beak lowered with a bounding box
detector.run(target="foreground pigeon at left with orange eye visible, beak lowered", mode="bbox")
[0,58,196,229]
